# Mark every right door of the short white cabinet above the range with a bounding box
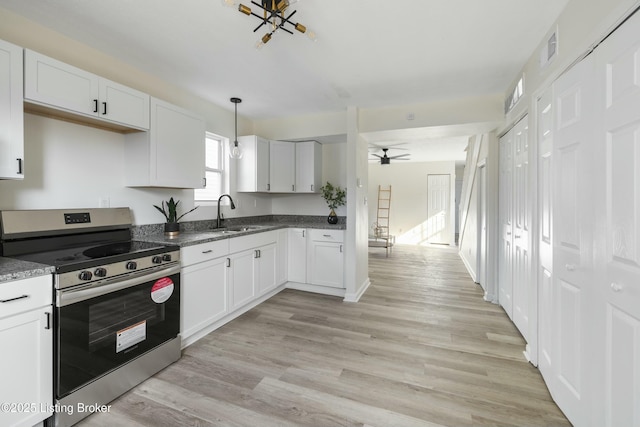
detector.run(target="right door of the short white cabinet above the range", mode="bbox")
[98,78,151,130]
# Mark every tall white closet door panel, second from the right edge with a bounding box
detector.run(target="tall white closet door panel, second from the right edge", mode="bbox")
[548,56,595,426]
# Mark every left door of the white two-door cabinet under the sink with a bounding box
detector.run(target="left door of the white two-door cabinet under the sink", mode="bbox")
[227,249,257,311]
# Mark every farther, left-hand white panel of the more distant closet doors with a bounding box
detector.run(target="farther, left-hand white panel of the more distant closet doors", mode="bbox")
[498,129,513,319]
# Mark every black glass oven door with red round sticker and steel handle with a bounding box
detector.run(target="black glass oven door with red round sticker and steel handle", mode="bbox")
[54,266,180,399]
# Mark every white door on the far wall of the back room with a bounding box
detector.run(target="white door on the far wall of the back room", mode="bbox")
[427,175,451,244]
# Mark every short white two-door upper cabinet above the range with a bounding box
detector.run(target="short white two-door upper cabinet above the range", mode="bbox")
[24,50,149,130]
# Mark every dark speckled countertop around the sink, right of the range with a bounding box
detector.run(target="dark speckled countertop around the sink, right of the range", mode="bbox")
[136,222,346,248]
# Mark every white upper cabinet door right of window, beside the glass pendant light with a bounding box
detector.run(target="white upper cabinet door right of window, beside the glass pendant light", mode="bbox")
[236,135,270,193]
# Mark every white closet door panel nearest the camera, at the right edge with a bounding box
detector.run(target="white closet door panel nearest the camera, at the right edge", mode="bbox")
[594,14,640,427]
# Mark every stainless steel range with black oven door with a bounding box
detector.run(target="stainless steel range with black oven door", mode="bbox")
[0,208,180,426]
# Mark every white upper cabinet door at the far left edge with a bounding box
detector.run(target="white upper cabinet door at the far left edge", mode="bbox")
[0,40,24,179]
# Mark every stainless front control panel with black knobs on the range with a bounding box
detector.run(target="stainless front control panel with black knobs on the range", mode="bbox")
[54,250,180,289]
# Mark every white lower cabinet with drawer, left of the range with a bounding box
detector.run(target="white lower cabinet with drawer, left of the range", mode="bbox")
[0,275,53,426]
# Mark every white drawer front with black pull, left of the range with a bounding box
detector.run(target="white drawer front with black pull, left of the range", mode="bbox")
[0,274,53,318]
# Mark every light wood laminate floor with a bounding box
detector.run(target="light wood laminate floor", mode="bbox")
[80,246,570,427]
